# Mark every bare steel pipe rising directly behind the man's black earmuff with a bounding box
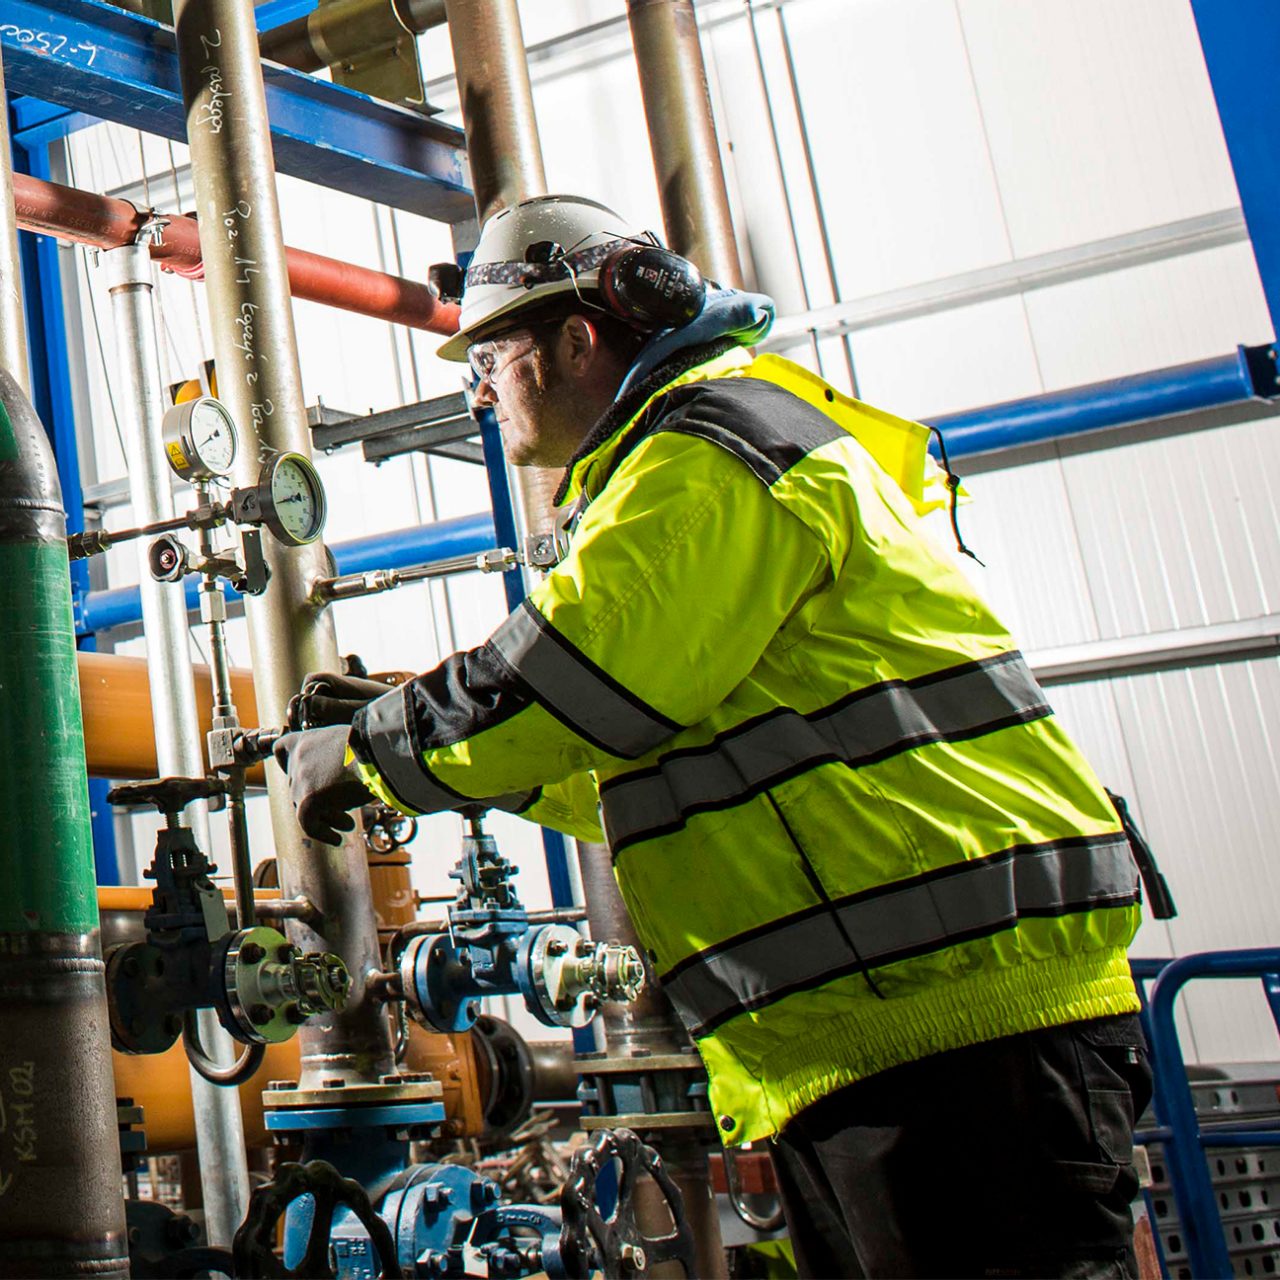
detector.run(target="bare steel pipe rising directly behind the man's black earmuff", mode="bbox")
[627,0,742,288]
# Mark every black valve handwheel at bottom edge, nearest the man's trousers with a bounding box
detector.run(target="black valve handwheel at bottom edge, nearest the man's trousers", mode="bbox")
[561,1129,694,1280]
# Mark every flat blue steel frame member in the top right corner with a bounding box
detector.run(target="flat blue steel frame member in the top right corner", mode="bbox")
[1192,0,1280,345]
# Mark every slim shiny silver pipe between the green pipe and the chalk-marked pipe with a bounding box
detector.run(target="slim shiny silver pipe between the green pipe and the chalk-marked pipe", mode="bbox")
[99,244,248,1247]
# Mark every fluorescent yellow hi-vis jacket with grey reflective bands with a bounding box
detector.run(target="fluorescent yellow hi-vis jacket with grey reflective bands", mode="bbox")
[352,346,1139,1143]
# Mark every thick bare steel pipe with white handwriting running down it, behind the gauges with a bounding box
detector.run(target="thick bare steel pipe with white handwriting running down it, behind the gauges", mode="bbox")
[174,0,393,1087]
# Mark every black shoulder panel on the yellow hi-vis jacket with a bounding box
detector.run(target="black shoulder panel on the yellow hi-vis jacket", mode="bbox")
[618,378,846,485]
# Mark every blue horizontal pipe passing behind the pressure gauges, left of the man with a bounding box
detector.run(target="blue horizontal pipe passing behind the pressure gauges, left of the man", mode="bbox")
[76,512,497,635]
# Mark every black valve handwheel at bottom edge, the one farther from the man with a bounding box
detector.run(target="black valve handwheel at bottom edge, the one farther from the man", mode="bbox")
[232,1160,404,1280]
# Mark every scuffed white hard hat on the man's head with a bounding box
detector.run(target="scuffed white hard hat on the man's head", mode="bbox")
[436,196,655,360]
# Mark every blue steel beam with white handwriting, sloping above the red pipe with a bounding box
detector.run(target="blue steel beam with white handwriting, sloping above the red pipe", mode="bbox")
[0,0,475,223]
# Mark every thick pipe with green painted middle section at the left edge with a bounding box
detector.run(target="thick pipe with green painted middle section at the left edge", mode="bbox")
[0,369,128,1277]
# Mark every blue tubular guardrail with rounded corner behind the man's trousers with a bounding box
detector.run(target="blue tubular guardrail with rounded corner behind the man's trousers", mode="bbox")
[1140,947,1280,1280]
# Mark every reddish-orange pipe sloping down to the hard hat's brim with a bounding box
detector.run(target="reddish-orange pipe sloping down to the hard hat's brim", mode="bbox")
[13,174,458,334]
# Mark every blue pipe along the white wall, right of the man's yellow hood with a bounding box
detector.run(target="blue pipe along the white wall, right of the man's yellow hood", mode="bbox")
[924,347,1274,458]
